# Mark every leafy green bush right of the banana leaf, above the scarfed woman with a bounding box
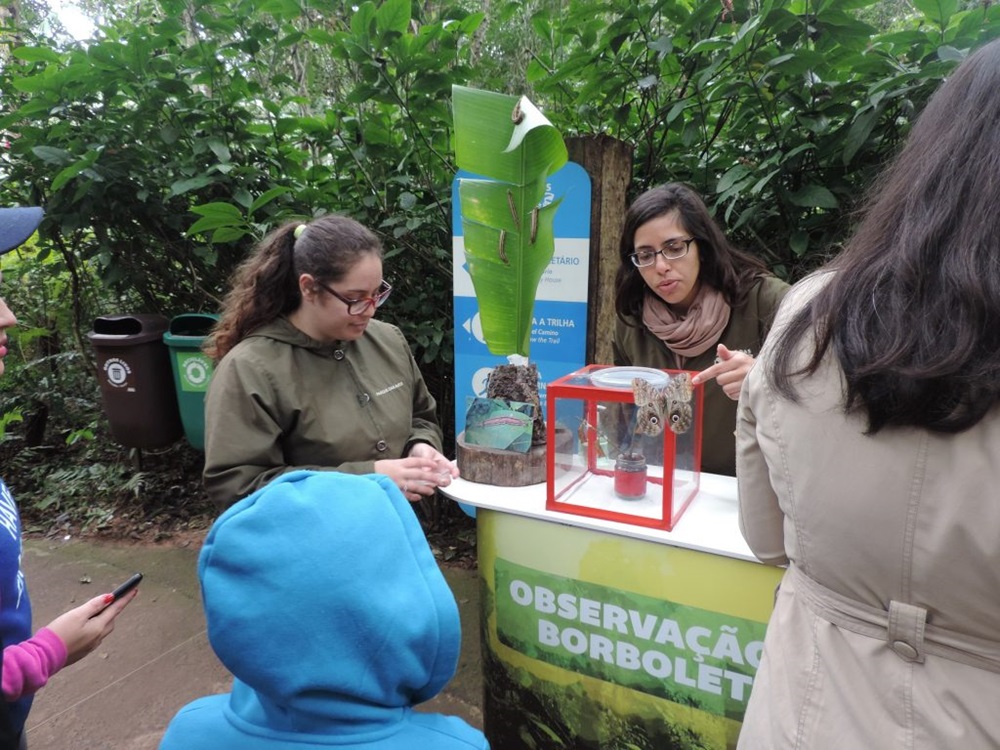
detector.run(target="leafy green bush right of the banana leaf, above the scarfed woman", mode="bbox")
[528,0,1000,278]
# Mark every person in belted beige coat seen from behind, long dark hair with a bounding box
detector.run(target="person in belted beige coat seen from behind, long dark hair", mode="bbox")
[737,36,1000,750]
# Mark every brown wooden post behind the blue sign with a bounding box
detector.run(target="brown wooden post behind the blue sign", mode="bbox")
[566,135,633,365]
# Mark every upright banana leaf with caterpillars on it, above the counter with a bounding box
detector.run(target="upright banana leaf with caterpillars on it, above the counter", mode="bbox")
[452,86,568,357]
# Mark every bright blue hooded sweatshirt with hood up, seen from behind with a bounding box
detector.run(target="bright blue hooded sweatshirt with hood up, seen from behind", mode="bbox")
[160,471,489,750]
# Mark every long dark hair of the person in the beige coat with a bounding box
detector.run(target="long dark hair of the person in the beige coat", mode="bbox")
[768,41,1000,434]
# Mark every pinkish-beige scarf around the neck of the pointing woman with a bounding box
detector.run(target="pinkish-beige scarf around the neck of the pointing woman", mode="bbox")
[642,284,732,369]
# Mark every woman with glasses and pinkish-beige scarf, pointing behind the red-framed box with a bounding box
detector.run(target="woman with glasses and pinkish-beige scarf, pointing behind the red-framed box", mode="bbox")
[613,183,788,475]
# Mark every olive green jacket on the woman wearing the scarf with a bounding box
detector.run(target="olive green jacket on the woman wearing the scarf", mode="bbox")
[612,276,788,476]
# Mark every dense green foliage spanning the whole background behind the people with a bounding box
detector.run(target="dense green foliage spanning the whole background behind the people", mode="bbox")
[0,0,1000,528]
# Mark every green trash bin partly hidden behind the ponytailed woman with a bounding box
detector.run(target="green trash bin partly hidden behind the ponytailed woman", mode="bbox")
[163,313,219,451]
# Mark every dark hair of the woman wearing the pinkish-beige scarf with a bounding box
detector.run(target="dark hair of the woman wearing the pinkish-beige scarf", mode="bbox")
[615,182,768,326]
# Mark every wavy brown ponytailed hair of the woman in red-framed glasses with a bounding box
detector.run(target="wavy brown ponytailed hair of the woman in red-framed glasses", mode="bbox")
[204,215,382,361]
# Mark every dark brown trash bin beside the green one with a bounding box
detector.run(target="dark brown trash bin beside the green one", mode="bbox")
[87,315,182,449]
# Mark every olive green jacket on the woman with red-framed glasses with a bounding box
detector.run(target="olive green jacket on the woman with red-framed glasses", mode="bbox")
[204,318,441,507]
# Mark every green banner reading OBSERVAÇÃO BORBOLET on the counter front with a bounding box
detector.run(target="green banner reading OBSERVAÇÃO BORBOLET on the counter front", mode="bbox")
[495,557,766,721]
